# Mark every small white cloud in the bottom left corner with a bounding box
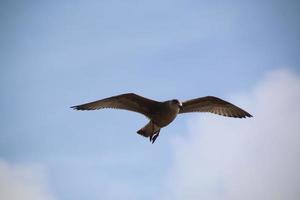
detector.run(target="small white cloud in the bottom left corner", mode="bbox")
[0,160,54,200]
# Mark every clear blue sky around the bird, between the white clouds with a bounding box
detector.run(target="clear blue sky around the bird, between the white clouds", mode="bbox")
[0,0,300,200]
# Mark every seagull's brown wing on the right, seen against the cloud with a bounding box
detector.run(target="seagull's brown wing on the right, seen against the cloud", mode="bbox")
[179,96,252,118]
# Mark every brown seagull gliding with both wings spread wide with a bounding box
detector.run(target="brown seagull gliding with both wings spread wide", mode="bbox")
[71,93,252,144]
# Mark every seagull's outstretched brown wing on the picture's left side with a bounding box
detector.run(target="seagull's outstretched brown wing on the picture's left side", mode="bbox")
[71,93,159,118]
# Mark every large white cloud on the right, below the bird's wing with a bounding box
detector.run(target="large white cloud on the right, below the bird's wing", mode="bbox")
[163,69,300,200]
